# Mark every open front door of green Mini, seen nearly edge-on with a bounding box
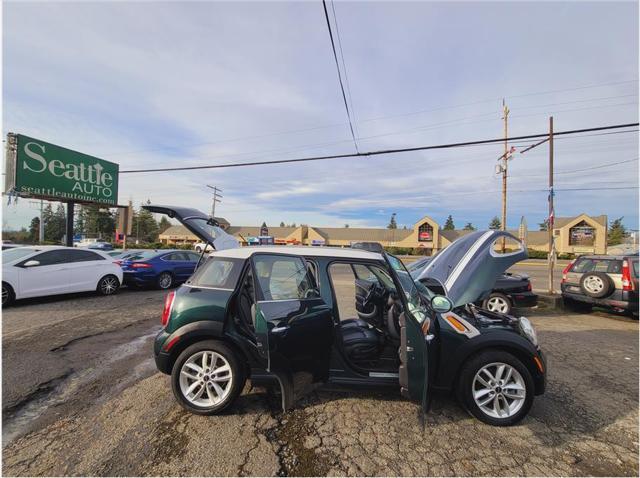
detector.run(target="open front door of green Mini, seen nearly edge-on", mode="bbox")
[385,254,432,413]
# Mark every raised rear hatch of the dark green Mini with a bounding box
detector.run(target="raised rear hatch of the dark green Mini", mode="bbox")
[142,204,240,251]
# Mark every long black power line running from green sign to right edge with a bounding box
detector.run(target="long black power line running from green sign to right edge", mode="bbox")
[120,123,639,174]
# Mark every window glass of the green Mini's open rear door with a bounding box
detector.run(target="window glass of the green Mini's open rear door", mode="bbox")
[254,255,316,300]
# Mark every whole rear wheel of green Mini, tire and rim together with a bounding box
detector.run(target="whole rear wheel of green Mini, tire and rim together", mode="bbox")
[171,340,246,415]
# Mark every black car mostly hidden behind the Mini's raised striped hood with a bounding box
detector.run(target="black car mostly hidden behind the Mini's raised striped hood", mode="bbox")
[407,255,538,314]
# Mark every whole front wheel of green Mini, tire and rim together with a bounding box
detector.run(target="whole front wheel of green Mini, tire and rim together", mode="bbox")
[457,350,534,426]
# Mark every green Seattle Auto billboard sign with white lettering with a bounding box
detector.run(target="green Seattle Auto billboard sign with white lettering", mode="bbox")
[5,133,118,206]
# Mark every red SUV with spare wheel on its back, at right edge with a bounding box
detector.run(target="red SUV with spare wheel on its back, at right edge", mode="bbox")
[560,255,638,318]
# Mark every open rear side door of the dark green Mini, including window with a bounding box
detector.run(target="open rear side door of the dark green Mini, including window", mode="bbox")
[251,253,333,410]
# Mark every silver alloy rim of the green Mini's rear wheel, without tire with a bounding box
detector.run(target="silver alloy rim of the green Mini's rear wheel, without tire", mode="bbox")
[180,350,233,407]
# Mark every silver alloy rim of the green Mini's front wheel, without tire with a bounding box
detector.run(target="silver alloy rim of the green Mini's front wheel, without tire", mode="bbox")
[471,362,527,418]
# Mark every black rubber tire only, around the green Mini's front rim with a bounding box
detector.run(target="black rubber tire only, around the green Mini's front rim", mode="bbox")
[456,349,534,427]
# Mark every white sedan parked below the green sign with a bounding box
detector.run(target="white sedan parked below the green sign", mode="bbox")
[2,246,122,306]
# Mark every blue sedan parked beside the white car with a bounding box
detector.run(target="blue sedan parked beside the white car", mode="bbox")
[118,249,200,289]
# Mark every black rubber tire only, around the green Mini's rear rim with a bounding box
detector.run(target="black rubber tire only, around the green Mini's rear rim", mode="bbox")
[171,340,247,415]
